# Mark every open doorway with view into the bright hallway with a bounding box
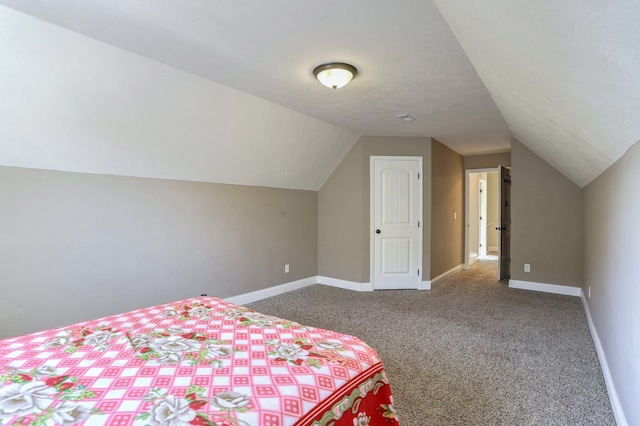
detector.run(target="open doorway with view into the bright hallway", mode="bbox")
[463,168,501,276]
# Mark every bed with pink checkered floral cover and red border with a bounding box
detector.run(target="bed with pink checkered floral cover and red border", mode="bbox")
[0,297,398,426]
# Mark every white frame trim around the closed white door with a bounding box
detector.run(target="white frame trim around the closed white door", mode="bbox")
[369,155,425,290]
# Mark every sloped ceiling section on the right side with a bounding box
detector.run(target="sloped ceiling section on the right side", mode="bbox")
[435,0,640,186]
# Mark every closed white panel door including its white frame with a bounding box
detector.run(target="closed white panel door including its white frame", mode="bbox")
[371,157,422,290]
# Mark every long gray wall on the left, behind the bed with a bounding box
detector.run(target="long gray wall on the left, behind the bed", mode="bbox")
[0,167,318,337]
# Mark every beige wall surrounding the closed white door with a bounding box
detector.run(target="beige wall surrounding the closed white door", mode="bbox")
[318,136,431,283]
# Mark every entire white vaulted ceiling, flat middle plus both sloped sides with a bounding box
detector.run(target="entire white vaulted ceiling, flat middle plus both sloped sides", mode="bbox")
[0,0,640,189]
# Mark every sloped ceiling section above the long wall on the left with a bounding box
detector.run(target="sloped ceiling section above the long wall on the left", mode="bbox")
[0,7,358,190]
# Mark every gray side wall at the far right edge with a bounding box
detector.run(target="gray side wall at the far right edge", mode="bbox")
[583,143,640,425]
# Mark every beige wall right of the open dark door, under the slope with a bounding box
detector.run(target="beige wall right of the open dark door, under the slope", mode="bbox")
[511,140,583,287]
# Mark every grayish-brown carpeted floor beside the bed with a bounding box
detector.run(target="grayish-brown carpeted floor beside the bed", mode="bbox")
[248,262,615,426]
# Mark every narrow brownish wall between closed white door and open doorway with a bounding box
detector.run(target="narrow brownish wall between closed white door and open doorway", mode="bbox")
[431,139,465,278]
